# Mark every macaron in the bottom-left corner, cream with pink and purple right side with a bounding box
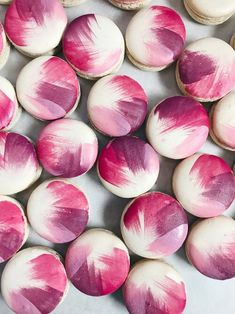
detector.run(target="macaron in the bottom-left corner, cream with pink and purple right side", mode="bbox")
[1,246,68,314]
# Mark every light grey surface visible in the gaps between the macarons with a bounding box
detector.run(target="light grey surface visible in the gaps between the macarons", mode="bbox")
[0,0,235,314]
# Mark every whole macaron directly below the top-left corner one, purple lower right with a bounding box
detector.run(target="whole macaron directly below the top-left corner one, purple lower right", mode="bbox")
[16,56,80,120]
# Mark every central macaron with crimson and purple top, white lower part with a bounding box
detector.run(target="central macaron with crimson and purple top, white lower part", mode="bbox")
[97,136,159,198]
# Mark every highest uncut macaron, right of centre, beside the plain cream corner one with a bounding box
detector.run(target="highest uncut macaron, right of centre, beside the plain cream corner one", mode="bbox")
[126,5,186,71]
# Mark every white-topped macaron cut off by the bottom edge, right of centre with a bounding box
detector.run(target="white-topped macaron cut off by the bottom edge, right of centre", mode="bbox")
[123,260,186,314]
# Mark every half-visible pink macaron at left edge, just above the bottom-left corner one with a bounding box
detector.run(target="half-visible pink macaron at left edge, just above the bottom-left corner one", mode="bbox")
[0,195,29,263]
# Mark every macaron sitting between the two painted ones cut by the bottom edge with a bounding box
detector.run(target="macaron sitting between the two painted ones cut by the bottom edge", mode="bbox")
[65,229,130,296]
